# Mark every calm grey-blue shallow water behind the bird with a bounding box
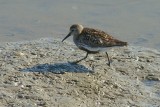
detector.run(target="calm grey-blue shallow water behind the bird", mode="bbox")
[0,0,160,49]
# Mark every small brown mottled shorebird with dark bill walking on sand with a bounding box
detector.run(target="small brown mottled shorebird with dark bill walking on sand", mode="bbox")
[62,24,127,66]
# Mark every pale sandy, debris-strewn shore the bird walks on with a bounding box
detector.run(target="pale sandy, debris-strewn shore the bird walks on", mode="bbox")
[0,38,160,107]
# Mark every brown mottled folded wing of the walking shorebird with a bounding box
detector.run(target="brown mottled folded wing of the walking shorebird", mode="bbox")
[79,28,126,47]
